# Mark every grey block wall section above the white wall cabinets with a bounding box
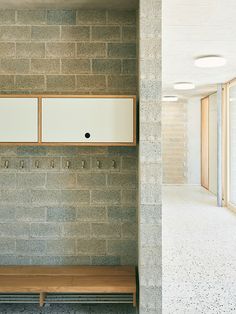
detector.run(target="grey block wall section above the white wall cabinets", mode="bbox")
[0,10,137,94]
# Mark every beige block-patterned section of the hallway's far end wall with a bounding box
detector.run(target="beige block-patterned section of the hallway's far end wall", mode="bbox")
[162,100,187,184]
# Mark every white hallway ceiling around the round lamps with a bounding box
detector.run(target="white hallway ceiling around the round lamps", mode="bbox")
[162,0,236,97]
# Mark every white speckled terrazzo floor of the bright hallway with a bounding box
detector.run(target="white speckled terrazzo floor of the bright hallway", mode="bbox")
[162,186,236,314]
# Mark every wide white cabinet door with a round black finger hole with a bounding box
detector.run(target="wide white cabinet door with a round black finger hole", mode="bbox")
[42,96,135,144]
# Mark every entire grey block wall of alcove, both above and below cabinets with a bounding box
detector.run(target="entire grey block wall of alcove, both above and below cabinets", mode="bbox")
[0,10,137,264]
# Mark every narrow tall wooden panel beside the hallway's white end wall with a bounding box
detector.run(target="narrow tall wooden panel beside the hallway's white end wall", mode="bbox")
[201,97,209,189]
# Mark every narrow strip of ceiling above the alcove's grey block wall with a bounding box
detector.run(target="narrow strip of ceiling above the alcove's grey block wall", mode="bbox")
[0,0,139,9]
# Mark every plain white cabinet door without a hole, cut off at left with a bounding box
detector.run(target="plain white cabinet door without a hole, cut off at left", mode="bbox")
[0,97,38,143]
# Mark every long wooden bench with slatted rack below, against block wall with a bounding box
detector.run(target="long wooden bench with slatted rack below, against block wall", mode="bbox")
[0,266,136,306]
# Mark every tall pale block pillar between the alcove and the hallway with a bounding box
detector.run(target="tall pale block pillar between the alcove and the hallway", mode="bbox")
[139,0,162,314]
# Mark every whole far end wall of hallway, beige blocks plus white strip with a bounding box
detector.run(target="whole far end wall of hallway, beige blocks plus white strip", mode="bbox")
[162,98,201,185]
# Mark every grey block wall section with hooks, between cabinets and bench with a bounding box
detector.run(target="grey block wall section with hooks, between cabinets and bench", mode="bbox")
[0,147,137,265]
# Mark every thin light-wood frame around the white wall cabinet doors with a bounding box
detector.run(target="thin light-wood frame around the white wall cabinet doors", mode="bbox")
[0,94,137,146]
